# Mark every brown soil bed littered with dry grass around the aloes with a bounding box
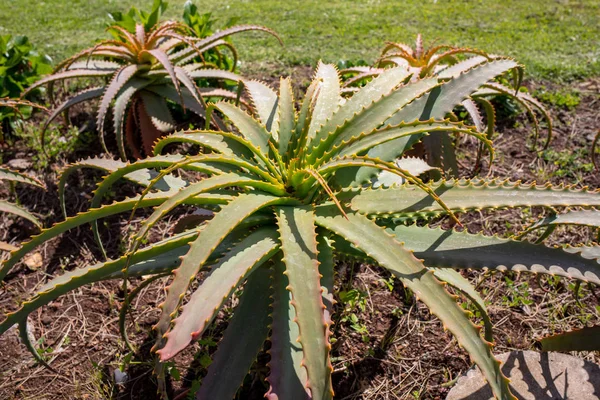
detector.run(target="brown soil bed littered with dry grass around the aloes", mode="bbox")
[0,67,600,399]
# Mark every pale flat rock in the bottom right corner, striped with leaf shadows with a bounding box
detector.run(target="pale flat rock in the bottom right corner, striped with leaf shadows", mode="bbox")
[446,351,600,400]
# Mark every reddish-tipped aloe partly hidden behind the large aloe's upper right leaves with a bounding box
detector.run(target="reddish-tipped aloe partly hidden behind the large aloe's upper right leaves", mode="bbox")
[340,34,552,176]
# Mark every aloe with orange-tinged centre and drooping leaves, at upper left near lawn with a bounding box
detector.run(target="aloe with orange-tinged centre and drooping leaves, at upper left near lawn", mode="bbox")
[29,21,277,160]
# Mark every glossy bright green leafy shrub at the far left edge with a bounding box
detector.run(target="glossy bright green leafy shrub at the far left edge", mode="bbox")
[0,35,52,137]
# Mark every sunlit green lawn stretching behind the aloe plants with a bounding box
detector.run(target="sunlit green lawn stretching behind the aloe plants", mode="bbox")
[0,0,600,80]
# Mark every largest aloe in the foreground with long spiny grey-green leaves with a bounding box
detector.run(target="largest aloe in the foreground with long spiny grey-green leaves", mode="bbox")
[0,59,600,399]
